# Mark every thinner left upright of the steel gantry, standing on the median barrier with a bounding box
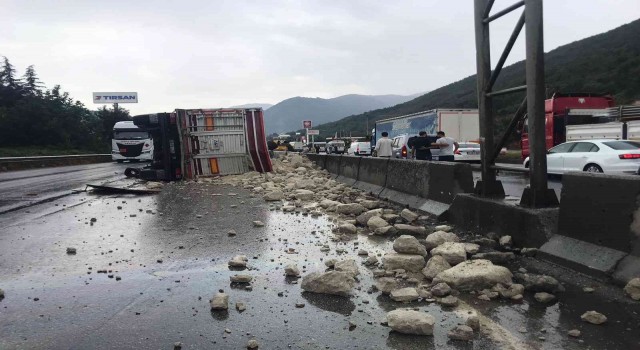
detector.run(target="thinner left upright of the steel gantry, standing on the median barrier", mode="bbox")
[474,0,504,198]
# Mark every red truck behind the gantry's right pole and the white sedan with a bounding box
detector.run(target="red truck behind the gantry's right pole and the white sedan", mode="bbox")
[520,93,614,160]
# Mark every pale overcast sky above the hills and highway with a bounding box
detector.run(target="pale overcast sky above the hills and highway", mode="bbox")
[0,0,640,114]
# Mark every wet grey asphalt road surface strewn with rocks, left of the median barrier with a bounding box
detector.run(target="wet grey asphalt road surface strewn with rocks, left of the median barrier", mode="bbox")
[0,163,640,349]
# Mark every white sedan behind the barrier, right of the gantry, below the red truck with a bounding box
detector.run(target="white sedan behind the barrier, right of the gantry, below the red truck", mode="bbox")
[524,139,640,174]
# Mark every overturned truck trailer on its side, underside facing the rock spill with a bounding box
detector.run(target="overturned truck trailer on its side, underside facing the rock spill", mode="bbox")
[175,108,272,178]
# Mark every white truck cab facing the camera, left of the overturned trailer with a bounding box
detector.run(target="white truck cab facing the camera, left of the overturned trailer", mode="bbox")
[111,121,153,163]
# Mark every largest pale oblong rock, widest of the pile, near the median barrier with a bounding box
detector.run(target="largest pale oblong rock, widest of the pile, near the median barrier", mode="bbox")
[433,260,512,291]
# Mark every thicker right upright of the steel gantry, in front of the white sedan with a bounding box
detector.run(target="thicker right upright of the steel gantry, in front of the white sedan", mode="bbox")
[521,0,558,208]
